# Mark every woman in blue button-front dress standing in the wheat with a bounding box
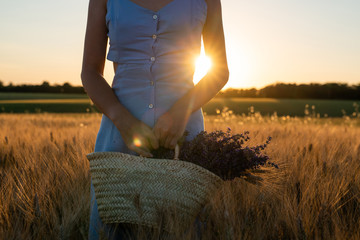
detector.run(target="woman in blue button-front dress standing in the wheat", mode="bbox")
[81,0,229,239]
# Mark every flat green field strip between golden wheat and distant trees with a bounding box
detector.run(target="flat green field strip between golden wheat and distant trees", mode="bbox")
[0,93,360,117]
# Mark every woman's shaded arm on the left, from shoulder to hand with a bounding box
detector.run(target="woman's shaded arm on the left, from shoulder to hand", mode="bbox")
[81,0,158,157]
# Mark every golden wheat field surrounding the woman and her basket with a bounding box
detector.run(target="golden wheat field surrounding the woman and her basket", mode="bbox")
[0,112,360,239]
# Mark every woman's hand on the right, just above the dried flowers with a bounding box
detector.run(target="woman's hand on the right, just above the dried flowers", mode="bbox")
[153,108,190,149]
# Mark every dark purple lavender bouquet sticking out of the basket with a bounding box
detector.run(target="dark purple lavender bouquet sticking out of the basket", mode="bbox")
[151,128,278,180]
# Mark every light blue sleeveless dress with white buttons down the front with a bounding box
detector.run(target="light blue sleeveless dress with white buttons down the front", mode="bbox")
[89,0,207,239]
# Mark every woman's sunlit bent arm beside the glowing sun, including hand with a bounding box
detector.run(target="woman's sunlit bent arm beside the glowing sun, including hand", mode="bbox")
[153,0,229,148]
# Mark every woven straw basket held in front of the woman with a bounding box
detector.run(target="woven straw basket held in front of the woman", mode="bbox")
[86,152,222,232]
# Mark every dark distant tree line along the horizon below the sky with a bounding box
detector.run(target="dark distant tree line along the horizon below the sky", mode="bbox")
[0,81,360,100]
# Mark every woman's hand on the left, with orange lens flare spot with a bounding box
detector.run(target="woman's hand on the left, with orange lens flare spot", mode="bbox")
[112,114,159,157]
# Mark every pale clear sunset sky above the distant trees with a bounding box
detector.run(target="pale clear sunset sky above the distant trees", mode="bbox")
[0,0,360,88]
